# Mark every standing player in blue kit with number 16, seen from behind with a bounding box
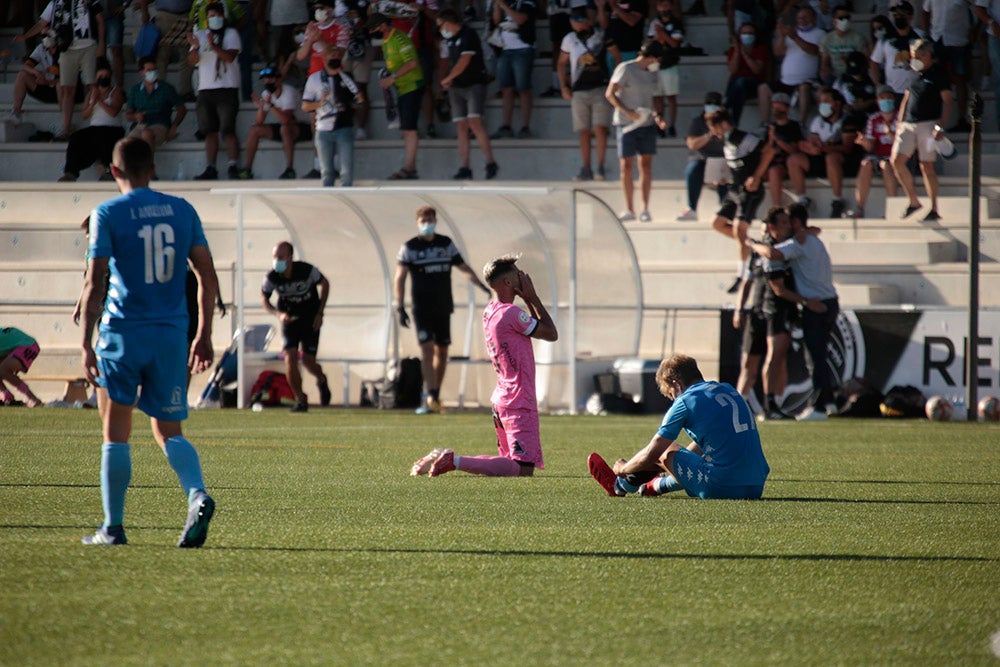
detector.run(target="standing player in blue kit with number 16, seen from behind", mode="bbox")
[81,137,219,548]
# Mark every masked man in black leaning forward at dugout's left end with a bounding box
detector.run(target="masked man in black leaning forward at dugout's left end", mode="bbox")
[260,241,330,412]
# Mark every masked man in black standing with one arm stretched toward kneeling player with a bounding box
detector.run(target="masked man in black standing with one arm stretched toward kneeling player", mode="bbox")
[393,206,492,415]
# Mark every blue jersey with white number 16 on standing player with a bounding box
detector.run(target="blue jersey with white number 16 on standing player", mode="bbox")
[90,188,208,328]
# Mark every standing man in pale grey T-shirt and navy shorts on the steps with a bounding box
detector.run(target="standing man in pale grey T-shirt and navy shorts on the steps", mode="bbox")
[604,41,667,222]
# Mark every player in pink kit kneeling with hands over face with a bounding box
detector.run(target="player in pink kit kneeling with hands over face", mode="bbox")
[410,255,559,477]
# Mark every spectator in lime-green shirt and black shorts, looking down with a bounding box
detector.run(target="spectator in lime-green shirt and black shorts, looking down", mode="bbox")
[368,13,424,180]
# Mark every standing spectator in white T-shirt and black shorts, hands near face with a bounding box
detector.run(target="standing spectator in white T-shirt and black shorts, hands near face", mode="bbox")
[188,2,241,181]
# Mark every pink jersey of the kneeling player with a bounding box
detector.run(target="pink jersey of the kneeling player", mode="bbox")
[483,301,538,411]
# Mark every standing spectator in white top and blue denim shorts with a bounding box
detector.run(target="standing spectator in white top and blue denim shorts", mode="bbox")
[490,0,537,139]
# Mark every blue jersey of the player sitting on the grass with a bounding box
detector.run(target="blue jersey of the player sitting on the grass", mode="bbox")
[657,382,771,486]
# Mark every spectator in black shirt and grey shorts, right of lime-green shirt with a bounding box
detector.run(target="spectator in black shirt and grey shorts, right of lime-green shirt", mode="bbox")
[437,7,500,180]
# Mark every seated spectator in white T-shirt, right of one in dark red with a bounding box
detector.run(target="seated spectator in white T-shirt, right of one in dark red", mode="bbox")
[763,7,823,121]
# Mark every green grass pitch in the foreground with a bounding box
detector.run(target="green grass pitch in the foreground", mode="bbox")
[0,408,1000,665]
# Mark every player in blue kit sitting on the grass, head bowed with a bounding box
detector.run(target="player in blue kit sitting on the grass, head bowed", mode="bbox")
[587,354,771,499]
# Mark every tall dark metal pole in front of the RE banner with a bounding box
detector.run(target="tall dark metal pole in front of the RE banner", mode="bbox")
[965,92,983,421]
